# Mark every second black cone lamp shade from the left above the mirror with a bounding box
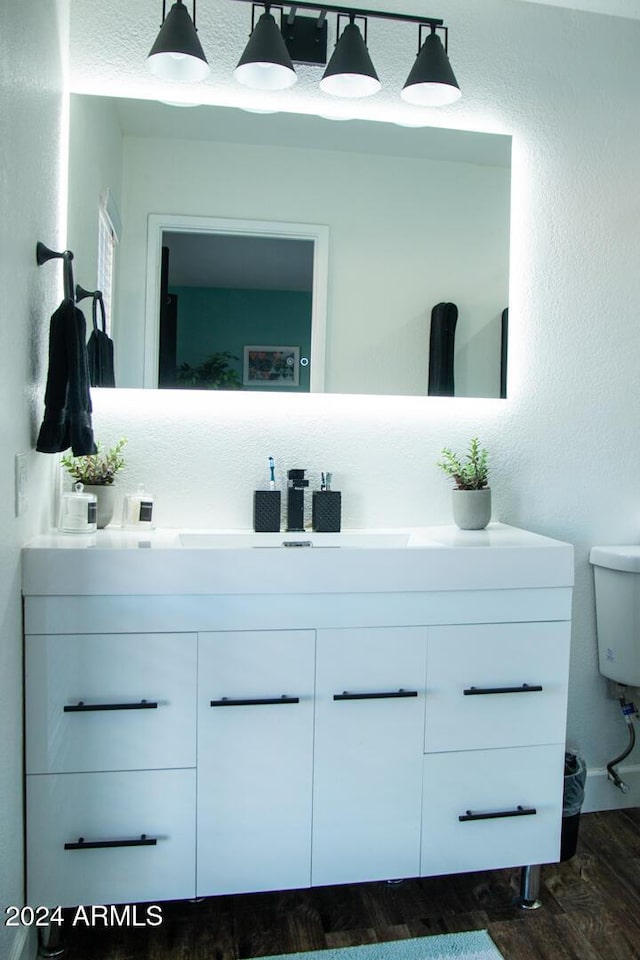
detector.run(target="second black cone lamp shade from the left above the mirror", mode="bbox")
[234,12,298,90]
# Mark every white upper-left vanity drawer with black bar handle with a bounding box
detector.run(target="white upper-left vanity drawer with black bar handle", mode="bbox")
[25,634,196,773]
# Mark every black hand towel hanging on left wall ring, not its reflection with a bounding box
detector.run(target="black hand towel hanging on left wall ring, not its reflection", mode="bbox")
[36,297,97,457]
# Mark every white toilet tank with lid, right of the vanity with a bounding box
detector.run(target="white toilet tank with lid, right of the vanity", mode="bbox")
[589,546,640,687]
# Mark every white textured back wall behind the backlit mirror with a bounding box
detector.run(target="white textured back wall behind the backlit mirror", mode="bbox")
[65,0,640,802]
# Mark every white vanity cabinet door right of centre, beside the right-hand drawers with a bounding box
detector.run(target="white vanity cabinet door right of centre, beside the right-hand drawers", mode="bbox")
[312,627,426,885]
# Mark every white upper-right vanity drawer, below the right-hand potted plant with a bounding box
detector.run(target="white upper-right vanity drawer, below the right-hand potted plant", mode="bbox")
[425,621,570,753]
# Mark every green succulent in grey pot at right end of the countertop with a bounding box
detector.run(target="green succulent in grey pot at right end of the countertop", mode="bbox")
[438,437,491,530]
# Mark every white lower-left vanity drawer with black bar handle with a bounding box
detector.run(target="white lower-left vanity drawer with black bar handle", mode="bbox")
[27,770,196,906]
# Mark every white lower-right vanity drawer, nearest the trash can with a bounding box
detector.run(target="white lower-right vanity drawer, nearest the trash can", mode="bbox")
[420,744,564,876]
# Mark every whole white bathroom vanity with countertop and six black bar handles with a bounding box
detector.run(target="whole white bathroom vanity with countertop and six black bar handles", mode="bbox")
[23,524,573,906]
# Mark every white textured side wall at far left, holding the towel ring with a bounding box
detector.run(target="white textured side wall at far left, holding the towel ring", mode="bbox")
[0,0,68,960]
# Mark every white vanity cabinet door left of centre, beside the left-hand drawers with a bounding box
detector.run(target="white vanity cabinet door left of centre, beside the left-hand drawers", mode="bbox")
[197,630,315,896]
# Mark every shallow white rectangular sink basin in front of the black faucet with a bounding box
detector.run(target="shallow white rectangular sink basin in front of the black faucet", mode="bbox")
[178,530,411,550]
